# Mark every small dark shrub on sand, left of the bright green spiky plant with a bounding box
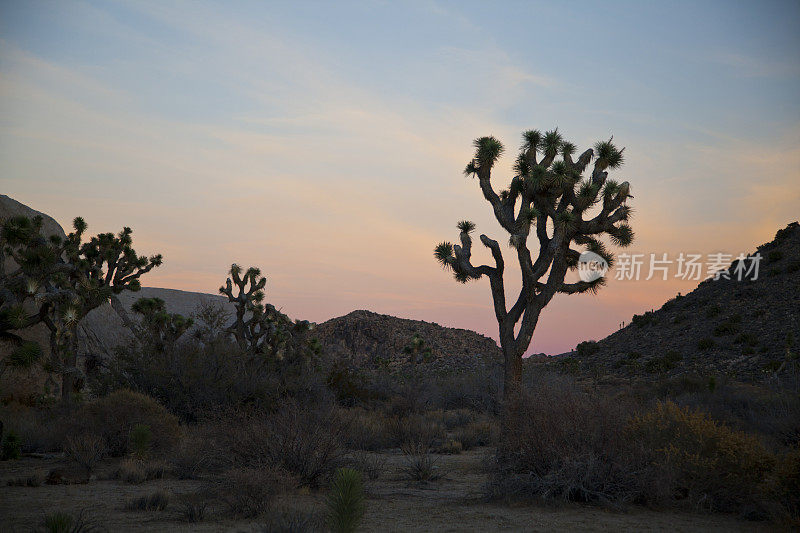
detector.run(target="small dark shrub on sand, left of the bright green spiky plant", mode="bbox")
[217,468,296,518]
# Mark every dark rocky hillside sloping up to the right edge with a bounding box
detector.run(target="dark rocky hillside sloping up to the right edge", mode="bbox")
[546,222,800,380]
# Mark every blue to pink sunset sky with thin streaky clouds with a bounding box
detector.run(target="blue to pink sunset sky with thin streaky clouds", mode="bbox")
[0,0,800,353]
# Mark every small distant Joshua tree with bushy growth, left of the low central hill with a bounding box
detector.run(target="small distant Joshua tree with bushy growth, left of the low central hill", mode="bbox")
[219,263,311,358]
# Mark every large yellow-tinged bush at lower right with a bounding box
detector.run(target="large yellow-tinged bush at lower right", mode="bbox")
[626,401,773,510]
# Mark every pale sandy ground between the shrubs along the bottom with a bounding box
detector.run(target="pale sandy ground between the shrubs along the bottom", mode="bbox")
[0,450,771,532]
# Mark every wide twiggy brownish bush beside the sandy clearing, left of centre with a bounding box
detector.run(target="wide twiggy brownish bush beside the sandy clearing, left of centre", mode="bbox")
[199,401,348,487]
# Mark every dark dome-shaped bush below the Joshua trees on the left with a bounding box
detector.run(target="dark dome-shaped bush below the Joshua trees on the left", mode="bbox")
[70,390,181,457]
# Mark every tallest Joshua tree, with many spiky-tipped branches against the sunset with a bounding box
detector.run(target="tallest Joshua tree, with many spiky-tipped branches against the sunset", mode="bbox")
[434,129,633,405]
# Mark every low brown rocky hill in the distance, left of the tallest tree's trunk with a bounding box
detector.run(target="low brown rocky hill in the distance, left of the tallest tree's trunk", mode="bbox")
[314,311,502,372]
